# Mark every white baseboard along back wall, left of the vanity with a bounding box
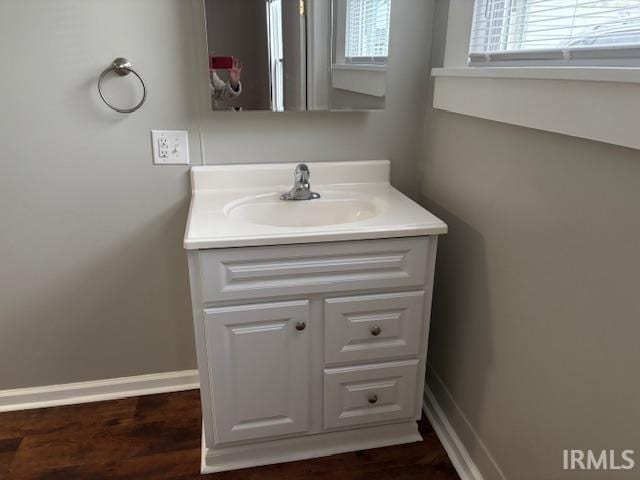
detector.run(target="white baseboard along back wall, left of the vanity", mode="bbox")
[0,370,200,412]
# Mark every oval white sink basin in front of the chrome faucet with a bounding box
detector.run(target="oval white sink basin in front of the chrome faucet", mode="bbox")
[225,192,380,227]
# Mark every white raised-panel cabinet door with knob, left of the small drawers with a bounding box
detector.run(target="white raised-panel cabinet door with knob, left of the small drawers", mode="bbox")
[205,300,310,443]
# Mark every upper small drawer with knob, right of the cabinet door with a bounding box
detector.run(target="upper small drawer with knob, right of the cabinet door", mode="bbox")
[324,291,424,364]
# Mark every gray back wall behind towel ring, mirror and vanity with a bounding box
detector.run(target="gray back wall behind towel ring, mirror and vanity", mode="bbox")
[0,0,430,390]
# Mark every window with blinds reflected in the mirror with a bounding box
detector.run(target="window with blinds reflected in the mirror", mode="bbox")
[345,0,391,63]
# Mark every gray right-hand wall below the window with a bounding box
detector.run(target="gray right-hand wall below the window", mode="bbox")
[421,2,640,480]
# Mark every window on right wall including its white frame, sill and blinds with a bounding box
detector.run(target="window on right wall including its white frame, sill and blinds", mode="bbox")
[432,0,640,150]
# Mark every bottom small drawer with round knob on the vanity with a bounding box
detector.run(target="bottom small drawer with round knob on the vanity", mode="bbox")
[324,360,419,428]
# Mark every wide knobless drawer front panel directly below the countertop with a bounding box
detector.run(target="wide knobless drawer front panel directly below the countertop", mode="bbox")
[198,237,434,302]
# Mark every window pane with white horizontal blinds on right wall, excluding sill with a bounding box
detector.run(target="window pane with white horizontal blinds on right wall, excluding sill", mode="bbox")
[469,0,640,66]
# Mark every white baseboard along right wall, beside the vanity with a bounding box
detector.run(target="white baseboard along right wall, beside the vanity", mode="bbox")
[423,365,505,480]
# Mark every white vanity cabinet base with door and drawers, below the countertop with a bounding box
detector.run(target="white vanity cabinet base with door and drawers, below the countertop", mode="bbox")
[188,236,437,473]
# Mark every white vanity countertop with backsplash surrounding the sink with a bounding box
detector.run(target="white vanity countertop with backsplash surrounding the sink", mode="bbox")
[184,160,447,250]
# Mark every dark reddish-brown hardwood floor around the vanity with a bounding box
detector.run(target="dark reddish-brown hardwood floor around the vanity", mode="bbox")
[0,390,458,480]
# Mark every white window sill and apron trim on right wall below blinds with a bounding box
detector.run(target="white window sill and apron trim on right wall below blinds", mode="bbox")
[432,67,640,149]
